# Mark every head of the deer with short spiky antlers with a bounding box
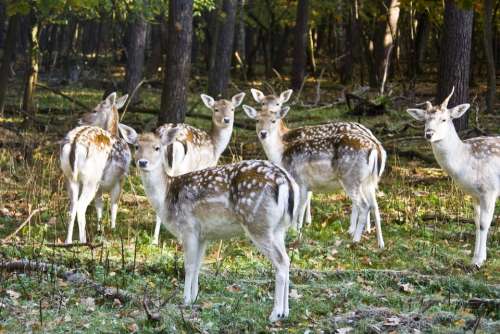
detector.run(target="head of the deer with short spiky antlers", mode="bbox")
[406,87,470,143]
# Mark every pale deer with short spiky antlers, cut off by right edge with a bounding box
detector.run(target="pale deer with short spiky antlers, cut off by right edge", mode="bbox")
[407,87,500,268]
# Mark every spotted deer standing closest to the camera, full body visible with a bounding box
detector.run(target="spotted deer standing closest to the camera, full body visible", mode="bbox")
[131,127,299,321]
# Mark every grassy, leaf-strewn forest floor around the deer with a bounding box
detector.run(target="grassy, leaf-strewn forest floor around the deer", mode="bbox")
[0,77,500,333]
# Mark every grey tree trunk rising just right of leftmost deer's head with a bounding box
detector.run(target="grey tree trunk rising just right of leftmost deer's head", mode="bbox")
[125,15,148,101]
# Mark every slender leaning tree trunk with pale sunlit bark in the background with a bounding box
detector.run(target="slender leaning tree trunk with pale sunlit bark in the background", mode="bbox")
[370,0,400,88]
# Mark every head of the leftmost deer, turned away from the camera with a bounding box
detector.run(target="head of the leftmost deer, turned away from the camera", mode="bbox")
[78,92,128,136]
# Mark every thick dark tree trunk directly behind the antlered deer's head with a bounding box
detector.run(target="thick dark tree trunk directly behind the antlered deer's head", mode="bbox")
[436,0,474,131]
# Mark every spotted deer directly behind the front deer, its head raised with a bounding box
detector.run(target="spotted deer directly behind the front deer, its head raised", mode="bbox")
[149,93,245,244]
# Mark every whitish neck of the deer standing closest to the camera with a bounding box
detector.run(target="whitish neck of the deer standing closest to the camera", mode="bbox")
[140,164,171,217]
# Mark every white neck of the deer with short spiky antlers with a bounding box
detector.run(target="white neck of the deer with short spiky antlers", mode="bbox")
[431,122,468,176]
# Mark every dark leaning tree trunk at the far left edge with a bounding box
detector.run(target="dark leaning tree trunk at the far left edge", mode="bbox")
[0,15,20,115]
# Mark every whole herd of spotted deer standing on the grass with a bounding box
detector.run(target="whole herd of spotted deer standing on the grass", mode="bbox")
[60,89,500,321]
